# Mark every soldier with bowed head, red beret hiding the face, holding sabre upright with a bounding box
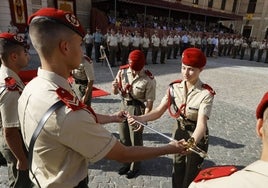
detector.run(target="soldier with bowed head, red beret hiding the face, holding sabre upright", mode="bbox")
[112,50,156,178]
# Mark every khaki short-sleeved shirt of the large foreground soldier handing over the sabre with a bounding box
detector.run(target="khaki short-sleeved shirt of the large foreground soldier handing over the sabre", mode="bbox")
[18,68,117,188]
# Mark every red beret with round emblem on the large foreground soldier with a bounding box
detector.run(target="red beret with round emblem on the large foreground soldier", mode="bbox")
[28,8,85,37]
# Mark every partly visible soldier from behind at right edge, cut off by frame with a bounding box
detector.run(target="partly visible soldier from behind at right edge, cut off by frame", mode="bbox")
[189,93,268,188]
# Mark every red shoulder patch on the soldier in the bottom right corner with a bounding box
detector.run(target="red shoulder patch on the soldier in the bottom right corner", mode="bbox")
[194,165,237,182]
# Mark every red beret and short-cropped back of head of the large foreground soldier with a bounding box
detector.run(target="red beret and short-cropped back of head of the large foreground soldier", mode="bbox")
[28,8,85,57]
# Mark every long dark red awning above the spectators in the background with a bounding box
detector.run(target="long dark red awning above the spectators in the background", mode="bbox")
[118,0,243,20]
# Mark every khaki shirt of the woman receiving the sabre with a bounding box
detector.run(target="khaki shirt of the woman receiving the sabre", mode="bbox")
[161,80,214,121]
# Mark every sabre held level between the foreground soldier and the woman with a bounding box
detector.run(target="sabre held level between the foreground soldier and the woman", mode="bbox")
[129,117,208,158]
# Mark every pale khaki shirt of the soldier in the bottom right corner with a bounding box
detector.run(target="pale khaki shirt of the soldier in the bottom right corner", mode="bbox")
[189,160,268,188]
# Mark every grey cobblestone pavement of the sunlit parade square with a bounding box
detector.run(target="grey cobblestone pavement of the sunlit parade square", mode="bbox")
[0,50,268,188]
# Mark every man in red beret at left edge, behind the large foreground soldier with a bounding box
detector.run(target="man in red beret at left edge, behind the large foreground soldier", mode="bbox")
[0,33,32,188]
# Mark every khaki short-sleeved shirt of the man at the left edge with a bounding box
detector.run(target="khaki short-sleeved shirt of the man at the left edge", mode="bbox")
[0,65,24,128]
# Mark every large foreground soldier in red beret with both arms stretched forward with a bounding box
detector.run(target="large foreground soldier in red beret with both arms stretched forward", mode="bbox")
[18,8,185,188]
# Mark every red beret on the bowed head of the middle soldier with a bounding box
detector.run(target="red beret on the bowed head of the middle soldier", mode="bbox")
[128,50,145,71]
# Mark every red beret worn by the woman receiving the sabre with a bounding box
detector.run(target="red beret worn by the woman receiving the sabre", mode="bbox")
[181,48,207,68]
